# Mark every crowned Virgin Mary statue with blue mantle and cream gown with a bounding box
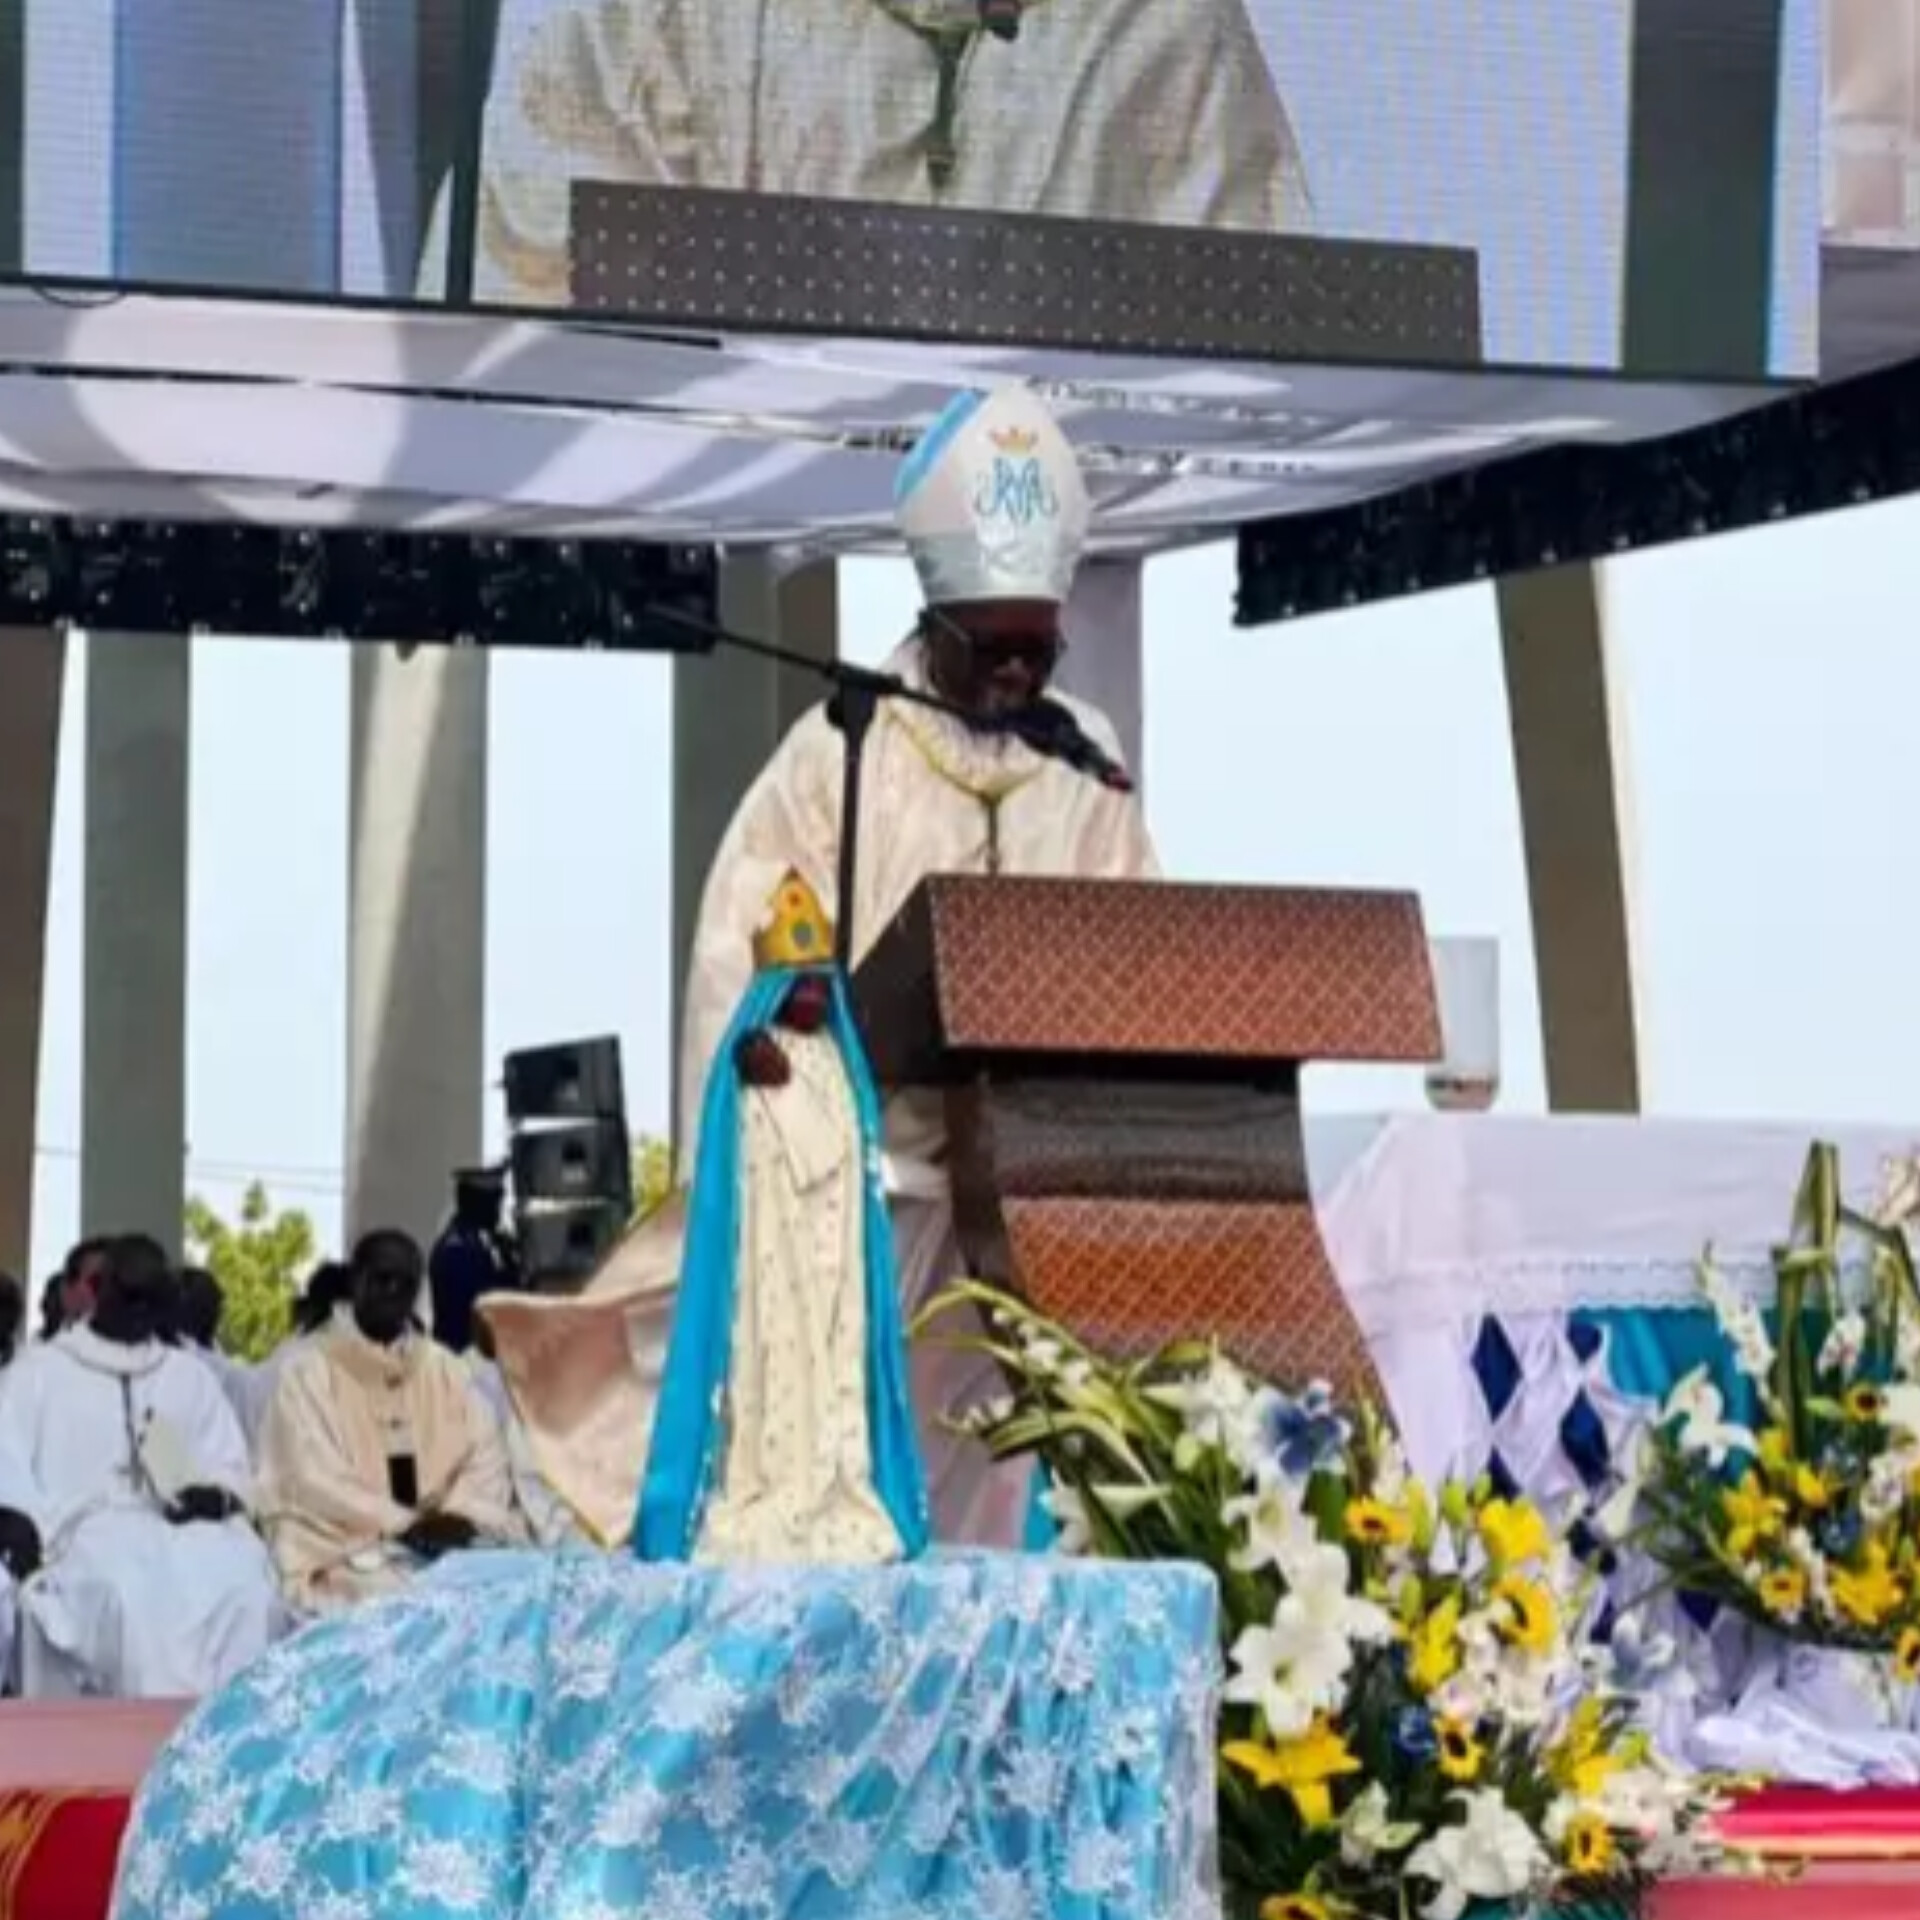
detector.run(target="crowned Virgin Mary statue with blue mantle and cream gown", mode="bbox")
[634,872,929,1565]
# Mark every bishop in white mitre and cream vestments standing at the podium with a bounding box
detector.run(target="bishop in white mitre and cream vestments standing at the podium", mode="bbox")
[488,386,1156,1546]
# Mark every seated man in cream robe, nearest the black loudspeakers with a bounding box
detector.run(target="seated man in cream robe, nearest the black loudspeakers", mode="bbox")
[259,1231,520,1617]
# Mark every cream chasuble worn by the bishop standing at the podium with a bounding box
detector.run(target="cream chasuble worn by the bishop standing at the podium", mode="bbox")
[488,643,1158,1546]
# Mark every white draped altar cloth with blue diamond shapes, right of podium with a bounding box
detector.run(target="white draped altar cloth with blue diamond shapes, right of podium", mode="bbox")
[1321,1116,1920,1788]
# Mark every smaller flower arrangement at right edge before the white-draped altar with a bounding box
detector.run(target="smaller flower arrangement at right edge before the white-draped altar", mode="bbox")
[1638,1144,1920,1680]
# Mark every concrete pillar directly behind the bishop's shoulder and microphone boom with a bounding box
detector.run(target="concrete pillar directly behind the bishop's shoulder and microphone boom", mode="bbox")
[672,553,839,1114]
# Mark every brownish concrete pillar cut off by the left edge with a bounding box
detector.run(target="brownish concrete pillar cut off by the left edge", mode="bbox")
[0,626,67,1279]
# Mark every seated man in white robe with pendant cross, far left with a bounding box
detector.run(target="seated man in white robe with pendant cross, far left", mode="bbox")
[0,1235,282,1699]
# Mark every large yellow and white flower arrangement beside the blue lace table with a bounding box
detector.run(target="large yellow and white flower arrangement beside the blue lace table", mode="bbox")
[922,1283,1743,1920]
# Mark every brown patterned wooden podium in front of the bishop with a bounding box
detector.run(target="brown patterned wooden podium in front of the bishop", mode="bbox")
[854,877,1440,1402]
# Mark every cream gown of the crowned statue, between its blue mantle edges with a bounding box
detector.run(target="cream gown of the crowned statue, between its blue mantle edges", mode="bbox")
[697,1029,900,1565]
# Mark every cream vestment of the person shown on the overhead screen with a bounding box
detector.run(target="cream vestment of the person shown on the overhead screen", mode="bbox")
[420,0,1311,307]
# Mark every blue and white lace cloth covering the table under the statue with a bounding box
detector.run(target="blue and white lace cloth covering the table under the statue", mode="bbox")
[115,1553,1219,1920]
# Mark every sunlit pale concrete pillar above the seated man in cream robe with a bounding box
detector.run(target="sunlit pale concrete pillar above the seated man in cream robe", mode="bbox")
[346,645,492,1240]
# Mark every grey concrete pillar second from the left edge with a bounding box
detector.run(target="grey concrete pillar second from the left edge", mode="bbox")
[81,634,194,1250]
